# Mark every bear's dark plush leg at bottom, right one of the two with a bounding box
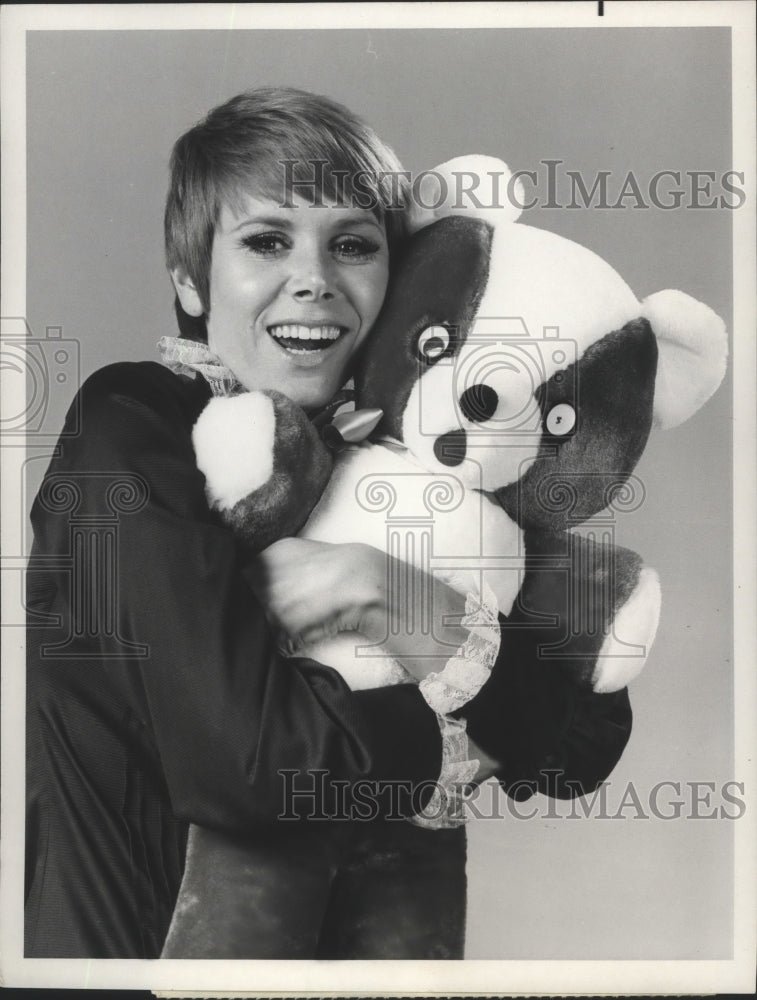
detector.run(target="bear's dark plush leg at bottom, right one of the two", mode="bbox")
[317,820,467,959]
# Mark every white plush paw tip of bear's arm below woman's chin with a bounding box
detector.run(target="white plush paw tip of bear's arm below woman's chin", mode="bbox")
[192,392,276,510]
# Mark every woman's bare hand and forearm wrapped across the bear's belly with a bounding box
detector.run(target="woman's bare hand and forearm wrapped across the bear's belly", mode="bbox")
[252,538,468,680]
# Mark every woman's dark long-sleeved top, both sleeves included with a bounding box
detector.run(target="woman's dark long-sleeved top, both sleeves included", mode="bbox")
[25,362,631,958]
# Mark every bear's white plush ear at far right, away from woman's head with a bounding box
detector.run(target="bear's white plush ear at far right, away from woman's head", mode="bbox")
[642,289,728,430]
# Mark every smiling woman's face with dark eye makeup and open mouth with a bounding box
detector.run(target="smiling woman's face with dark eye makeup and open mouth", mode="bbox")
[206,189,389,408]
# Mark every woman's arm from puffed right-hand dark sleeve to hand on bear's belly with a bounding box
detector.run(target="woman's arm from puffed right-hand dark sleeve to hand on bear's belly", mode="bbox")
[252,539,632,798]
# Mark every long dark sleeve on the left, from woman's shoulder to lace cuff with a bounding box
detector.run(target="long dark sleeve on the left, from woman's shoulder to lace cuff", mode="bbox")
[32,363,441,832]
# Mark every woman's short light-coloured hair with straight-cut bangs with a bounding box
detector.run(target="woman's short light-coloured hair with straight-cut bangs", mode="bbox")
[165,87,409,338]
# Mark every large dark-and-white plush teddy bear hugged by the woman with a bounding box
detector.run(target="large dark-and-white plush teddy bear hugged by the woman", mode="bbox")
[163,157,726,959]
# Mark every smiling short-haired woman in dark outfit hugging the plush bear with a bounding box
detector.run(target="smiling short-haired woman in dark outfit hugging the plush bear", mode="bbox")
[26,90,630,958]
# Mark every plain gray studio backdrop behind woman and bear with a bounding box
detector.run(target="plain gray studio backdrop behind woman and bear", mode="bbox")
[27,28,739,959]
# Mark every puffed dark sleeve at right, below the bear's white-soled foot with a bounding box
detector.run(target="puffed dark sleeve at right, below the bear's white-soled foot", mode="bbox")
[456,626,632,799]
